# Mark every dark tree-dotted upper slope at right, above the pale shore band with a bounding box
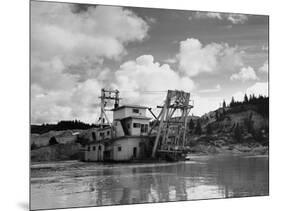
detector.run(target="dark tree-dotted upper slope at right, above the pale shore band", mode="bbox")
[197,97,269,135]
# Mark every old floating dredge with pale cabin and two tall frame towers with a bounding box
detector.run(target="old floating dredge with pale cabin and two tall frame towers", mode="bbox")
[82,89,193,161]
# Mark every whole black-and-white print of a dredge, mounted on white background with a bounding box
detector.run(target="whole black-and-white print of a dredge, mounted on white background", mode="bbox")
[29,0,270,210]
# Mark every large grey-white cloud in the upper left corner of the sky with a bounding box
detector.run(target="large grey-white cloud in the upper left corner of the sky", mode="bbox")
[31,2,148,62]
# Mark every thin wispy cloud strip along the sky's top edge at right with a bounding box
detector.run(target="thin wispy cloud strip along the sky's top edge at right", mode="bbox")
[189,12,248,24]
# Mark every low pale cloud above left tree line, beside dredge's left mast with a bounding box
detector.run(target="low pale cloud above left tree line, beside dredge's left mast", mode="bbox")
[31,79,102,123]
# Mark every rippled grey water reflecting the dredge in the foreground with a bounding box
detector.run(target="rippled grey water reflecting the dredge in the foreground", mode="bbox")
[31,155,269,209]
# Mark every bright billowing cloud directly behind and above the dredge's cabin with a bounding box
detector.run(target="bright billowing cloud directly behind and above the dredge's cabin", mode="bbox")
[113,55,195,107]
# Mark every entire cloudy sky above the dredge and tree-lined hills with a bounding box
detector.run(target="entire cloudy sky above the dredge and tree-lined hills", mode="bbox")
[31,1,268,124]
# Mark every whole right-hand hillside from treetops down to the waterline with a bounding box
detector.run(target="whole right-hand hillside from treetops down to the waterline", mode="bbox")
[185,96,269,154]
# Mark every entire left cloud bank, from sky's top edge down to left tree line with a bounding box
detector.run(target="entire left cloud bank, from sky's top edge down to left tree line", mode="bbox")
[31,1,149,123]
